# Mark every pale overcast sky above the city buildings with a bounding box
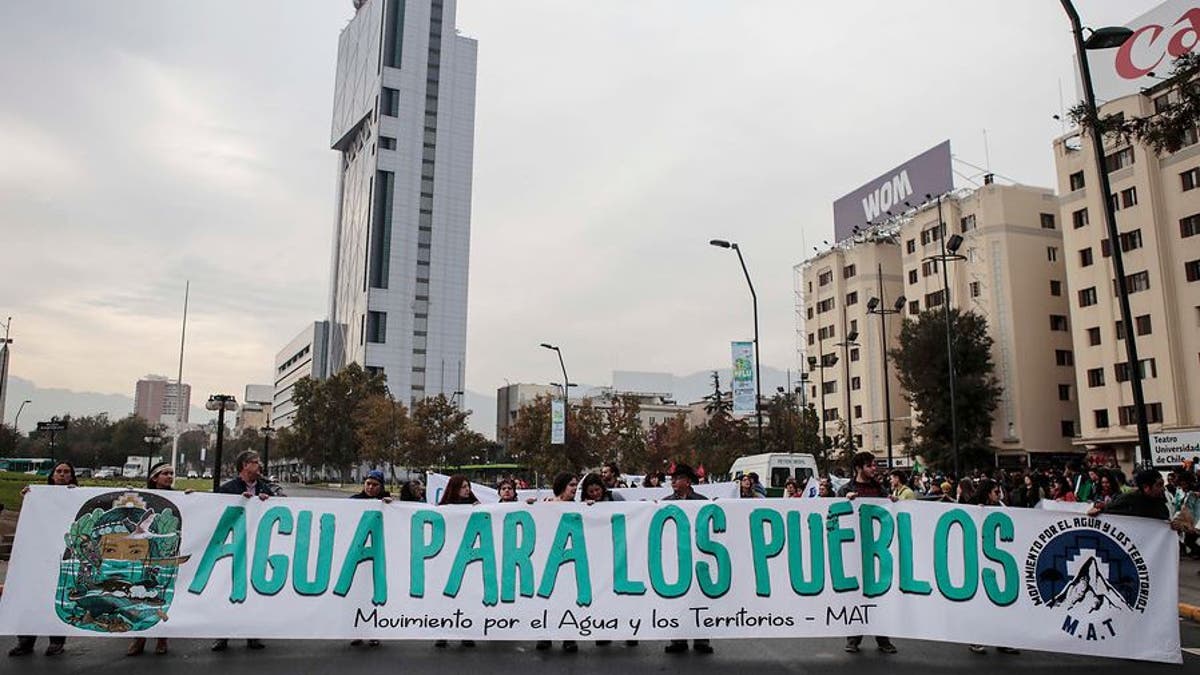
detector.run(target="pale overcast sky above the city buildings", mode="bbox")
[0,0,1157,425]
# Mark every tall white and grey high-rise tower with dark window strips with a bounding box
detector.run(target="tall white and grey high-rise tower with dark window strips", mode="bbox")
[328,0,478,402]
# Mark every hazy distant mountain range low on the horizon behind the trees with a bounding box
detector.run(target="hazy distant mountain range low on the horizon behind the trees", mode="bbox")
[4,366,799,438]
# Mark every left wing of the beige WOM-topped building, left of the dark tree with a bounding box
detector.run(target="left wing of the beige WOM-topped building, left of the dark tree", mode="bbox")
[796,237,912,465]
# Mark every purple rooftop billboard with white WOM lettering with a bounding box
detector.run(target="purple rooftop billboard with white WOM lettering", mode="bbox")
[833,141,954,241]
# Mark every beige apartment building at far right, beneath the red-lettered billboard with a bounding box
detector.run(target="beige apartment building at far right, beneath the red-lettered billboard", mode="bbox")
[1054,90,1200,466]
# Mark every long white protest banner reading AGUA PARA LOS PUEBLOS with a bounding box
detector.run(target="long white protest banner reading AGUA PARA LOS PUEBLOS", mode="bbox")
[0,486,1182,663]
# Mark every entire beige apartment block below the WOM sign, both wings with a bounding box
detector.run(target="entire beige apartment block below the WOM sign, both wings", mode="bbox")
[802,179,1079,466]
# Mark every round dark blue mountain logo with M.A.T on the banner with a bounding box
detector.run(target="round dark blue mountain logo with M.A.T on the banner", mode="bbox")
[1025,516,1150,640]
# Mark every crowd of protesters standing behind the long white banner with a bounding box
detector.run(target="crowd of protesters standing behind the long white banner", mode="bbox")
[8,450,1200,656]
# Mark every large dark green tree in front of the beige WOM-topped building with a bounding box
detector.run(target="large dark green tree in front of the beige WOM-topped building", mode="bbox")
[889,307,1001,471]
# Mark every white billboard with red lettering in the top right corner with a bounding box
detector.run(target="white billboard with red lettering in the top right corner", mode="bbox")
[1076,0,1200,103]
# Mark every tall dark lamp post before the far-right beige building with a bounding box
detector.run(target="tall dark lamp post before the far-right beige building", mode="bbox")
[1061,0,1150,465]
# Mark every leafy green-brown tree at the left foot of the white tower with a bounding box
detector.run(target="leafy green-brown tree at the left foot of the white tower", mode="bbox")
[289,363,388,478]
